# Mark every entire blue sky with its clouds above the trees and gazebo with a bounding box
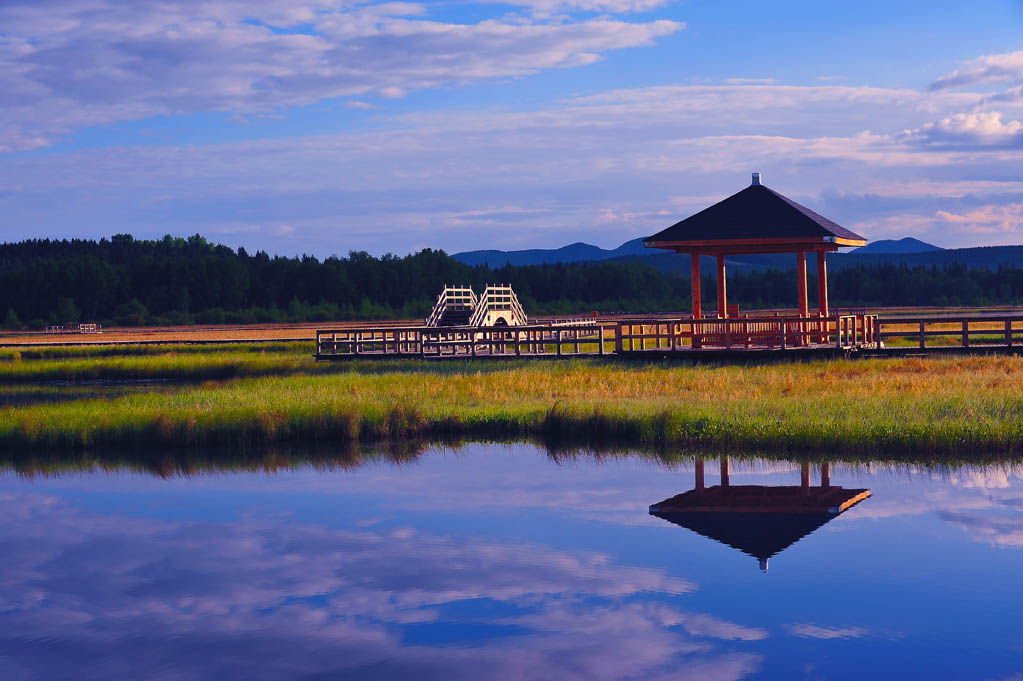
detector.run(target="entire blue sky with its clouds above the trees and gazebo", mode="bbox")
[0,0,1023,256]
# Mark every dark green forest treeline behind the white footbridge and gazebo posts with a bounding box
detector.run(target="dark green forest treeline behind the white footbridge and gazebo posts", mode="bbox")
[0,235,1023,328]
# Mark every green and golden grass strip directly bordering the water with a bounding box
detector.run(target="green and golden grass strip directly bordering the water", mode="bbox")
[0,356,1023,459]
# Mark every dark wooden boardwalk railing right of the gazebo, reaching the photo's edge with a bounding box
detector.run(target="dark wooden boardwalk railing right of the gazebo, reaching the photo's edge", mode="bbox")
[878,315,1023,350]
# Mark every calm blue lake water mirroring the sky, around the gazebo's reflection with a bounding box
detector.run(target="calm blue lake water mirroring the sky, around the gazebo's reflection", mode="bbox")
[0,445,1023,681]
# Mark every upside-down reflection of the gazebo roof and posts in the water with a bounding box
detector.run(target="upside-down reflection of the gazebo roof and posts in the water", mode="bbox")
[650,456,871,572]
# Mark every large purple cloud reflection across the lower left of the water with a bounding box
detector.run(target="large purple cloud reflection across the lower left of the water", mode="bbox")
[0,493,766,681]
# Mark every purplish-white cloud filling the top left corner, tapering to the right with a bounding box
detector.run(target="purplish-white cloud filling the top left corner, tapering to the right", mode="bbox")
[0,0,682,151]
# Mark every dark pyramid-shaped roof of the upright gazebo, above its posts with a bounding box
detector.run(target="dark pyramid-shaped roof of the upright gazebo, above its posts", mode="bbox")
[643,174,866,253]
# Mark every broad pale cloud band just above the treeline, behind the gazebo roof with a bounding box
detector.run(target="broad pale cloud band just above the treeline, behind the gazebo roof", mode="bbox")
[0,74,1023,250]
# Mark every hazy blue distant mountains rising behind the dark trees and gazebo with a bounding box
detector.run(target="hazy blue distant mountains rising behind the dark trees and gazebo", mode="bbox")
[452,236,1023,272]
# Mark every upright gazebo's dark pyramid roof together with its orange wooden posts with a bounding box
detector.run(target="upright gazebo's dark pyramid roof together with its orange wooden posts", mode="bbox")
[643,173,866,341]
